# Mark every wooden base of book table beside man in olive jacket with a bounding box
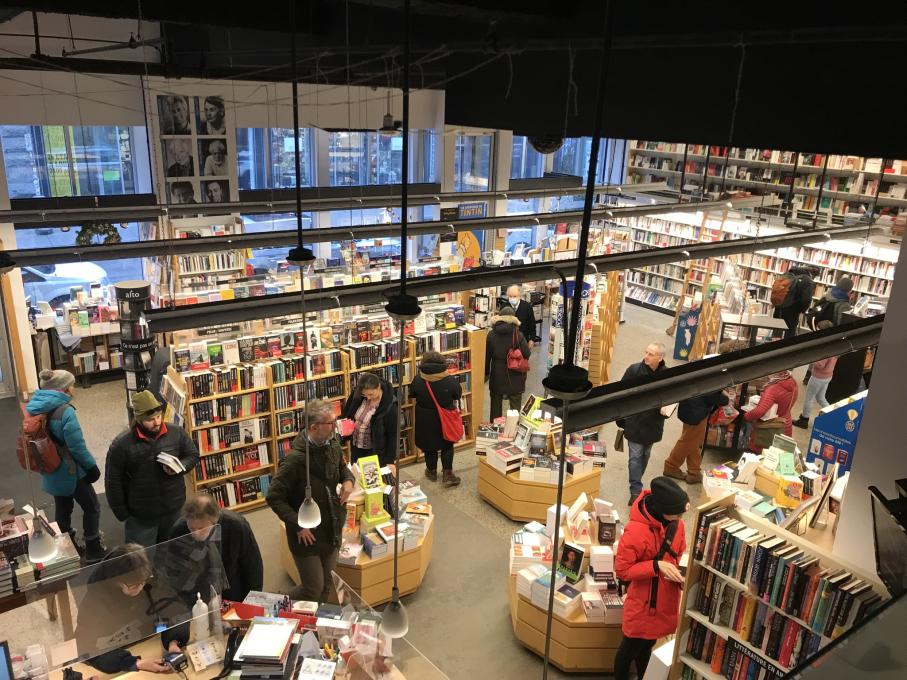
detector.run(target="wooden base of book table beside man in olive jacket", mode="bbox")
[280,522,435,607]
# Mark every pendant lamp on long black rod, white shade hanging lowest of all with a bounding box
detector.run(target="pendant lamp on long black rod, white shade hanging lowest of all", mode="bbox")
[381,0,422,638]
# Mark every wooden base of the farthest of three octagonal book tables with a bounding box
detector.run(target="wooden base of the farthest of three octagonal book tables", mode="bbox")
[478,458,601,522]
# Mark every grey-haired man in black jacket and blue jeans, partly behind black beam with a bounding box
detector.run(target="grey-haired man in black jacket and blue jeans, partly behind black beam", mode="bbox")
[617,342,667,505]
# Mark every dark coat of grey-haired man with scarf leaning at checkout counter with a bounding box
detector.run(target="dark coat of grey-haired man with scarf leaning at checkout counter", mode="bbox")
[170,510,264,602]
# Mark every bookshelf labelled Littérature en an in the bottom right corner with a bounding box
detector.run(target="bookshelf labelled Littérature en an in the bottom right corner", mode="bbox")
[668,494,886,680]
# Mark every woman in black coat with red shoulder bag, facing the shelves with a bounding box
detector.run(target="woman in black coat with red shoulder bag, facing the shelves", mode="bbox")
[409,352,463,487]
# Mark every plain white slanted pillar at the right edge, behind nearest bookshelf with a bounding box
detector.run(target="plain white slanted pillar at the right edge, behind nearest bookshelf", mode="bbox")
[834,244,907,573]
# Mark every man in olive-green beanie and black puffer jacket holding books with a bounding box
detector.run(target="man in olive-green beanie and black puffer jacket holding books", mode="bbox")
[104,390,198,547]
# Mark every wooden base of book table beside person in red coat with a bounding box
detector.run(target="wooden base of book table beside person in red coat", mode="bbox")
[507,576,621,673]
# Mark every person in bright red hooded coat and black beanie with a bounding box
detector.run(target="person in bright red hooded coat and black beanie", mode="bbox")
[614,477,690,680]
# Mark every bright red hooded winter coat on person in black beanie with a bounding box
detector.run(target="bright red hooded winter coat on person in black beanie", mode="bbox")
[614,490,687,640]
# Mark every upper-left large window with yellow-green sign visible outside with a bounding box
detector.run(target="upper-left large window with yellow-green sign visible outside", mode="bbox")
[0,125,151,198]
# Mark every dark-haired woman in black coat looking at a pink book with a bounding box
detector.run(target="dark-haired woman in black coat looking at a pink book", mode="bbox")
[340,372,398,465]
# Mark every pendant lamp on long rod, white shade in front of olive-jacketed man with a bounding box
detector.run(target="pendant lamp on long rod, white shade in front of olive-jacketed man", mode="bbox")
[287,0,321,529]
